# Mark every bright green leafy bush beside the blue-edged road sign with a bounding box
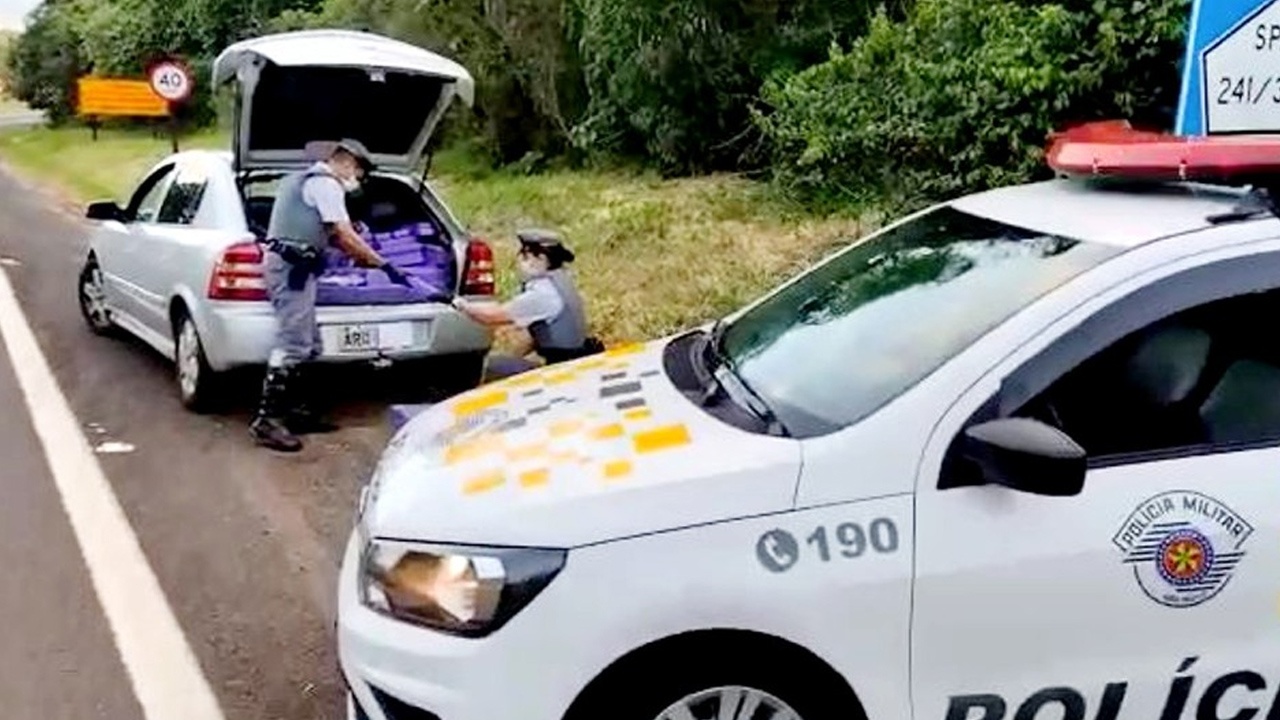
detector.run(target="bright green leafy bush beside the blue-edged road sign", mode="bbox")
[758,0,1187,209]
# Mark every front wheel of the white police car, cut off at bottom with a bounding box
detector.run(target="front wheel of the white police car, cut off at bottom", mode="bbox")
[564,635,864,720]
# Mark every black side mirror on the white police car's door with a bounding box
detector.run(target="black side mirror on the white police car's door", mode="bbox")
[963,418,1088,497]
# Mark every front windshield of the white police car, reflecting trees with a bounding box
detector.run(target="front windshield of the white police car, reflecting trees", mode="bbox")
[723,208,1119,437]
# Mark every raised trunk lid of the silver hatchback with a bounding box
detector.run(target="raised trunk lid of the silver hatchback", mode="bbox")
[214,29,475,173]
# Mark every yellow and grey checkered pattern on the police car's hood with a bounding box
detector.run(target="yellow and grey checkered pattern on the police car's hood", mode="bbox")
[443,346,692,495]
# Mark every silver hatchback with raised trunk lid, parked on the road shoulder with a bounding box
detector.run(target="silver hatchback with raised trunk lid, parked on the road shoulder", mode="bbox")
[79,31,494,411]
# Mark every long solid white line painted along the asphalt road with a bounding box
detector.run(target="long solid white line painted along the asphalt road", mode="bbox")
[0,270,224,720]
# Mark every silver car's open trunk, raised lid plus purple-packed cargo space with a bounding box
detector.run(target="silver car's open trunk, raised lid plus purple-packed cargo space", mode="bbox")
[212,29,475,305]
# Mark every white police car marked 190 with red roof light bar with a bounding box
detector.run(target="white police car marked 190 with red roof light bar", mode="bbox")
[338,126,1280,720]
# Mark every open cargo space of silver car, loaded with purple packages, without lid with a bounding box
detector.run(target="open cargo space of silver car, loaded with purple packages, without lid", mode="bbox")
[244,172,460,305]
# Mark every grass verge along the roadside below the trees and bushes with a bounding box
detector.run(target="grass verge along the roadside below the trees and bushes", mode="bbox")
[0,122,863,342]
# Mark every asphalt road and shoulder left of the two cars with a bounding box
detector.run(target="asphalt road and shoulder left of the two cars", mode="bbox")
[0,163,388,720]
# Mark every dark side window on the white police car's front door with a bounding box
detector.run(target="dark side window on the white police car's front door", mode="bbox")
[938,250,1280,489]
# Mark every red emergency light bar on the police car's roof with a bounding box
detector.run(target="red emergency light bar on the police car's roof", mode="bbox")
[1047,120,1280,180]
